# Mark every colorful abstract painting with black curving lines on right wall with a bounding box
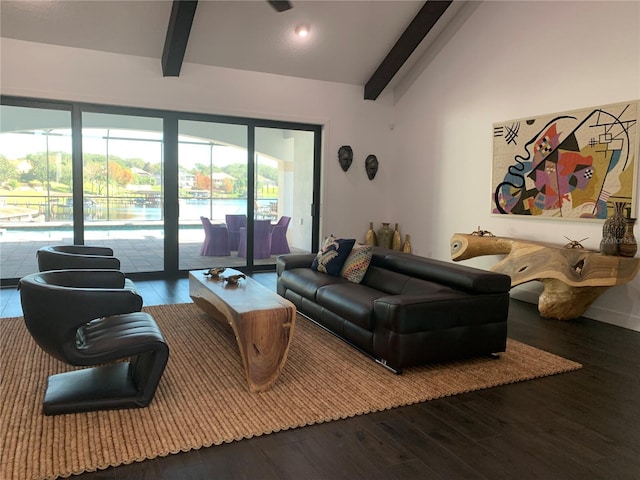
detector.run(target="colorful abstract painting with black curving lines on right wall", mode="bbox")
[491,100,640,220]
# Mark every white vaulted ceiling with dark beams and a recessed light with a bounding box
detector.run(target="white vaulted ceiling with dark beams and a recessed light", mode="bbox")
[0,0,466,99]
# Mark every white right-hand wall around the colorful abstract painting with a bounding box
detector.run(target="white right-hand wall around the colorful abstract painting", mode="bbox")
[390,1,640,331]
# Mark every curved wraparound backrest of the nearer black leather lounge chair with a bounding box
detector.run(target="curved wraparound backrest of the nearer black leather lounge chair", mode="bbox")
[18,270,142,365]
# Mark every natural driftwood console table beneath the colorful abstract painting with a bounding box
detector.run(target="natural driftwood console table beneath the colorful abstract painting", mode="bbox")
[451,233,640,320]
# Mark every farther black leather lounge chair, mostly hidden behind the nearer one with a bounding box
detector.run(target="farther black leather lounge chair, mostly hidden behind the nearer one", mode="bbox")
[36,245,120,272]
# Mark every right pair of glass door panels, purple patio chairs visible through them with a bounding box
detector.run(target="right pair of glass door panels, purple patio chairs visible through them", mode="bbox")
[178,120,316,270]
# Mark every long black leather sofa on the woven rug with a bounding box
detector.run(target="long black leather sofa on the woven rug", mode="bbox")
[277,247,511,373]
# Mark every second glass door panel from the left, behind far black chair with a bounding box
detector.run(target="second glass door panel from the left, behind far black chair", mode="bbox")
[82,112,164,273]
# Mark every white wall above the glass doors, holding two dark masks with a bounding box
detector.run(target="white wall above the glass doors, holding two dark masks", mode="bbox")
[0,38,394,244]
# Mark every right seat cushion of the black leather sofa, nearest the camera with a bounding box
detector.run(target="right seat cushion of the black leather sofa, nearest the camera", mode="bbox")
[316,281,386,330]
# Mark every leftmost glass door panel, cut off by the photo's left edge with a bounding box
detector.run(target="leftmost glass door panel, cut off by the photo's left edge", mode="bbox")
[0,105,73,278]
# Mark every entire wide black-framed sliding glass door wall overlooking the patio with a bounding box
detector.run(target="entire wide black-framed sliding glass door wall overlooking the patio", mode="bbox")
[0,96,321,285]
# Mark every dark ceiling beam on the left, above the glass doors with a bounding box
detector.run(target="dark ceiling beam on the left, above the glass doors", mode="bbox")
[162,0,198,77]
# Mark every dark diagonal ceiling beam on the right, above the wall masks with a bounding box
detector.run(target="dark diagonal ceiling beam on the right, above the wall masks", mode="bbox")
[364,0,452,100]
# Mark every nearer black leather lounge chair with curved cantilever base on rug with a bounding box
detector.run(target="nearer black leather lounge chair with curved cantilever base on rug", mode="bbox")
[18,270,169,415]
